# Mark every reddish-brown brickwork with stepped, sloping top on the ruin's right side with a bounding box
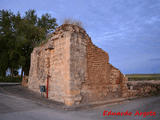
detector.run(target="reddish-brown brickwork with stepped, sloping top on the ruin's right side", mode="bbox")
[81,42,128,102]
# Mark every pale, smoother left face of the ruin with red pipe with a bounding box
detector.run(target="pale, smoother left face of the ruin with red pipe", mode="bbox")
[28,27,70,102]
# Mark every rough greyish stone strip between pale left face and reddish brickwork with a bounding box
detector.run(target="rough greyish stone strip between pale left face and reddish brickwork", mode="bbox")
[70,28,88,104]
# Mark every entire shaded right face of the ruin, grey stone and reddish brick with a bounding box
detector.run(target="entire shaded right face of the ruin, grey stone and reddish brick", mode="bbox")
[62,26,128,104]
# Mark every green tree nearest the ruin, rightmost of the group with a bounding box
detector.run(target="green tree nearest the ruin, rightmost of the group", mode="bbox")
[19,10,57,75]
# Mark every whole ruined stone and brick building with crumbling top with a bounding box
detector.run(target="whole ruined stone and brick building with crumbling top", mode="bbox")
[28,24,128,106]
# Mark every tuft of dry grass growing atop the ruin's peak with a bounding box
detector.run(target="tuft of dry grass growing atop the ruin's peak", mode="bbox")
[63,18,83,28]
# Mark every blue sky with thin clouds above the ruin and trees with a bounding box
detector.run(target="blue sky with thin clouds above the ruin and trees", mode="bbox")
[0,0,160,73]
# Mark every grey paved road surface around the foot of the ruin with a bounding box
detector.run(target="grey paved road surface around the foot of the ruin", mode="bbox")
[0,86,160,120]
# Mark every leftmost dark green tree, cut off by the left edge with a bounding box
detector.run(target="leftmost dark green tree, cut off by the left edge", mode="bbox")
[0,10,13,76]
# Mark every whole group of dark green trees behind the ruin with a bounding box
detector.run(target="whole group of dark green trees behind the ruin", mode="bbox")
[0,10,58,78]
